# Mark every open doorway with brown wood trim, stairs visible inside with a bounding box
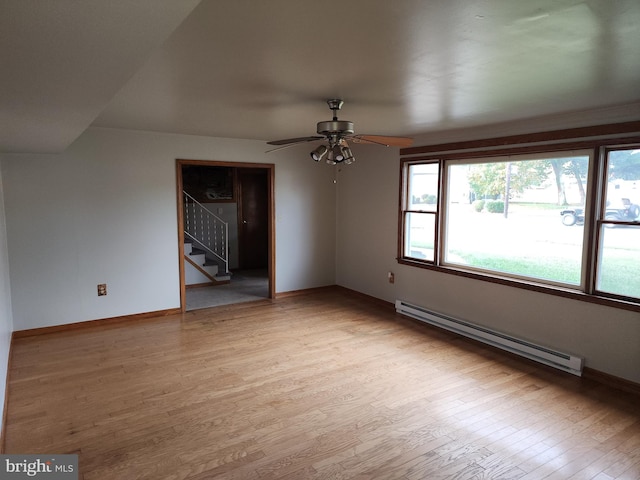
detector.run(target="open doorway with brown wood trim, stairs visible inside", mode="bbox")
[176,159,275,312]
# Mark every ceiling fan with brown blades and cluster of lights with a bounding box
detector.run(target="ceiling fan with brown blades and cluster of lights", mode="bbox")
[267,99,413,165]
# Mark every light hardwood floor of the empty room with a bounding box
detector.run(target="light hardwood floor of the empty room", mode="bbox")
[6,289,640,480]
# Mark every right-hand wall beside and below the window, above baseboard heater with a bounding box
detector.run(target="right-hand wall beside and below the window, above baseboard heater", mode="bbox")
[336,146,640,383]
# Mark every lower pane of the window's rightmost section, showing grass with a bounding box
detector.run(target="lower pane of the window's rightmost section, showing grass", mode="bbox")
[596,225,640,298]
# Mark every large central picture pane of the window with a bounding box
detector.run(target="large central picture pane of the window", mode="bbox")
[445,155,589,285]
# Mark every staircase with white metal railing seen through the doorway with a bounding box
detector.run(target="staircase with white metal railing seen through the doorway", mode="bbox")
[182,191,231,283]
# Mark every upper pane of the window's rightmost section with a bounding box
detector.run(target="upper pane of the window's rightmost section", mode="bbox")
[604,150,640,221]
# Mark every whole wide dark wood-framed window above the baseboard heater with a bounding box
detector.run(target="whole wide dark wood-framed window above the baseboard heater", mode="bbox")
[398,131,640,305]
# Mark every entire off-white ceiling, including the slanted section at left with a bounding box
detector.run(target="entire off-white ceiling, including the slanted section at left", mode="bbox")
[0,0,640,152]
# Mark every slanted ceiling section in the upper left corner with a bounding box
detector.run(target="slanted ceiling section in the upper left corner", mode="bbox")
[0,0,198,152]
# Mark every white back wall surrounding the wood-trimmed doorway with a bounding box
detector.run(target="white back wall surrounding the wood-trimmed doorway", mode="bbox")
[2,128,335,330]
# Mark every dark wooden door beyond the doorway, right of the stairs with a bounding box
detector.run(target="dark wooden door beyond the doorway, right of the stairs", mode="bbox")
[237,168,269,269]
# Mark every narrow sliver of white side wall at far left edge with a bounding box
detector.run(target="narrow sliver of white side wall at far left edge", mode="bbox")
[0,166,13,438]
